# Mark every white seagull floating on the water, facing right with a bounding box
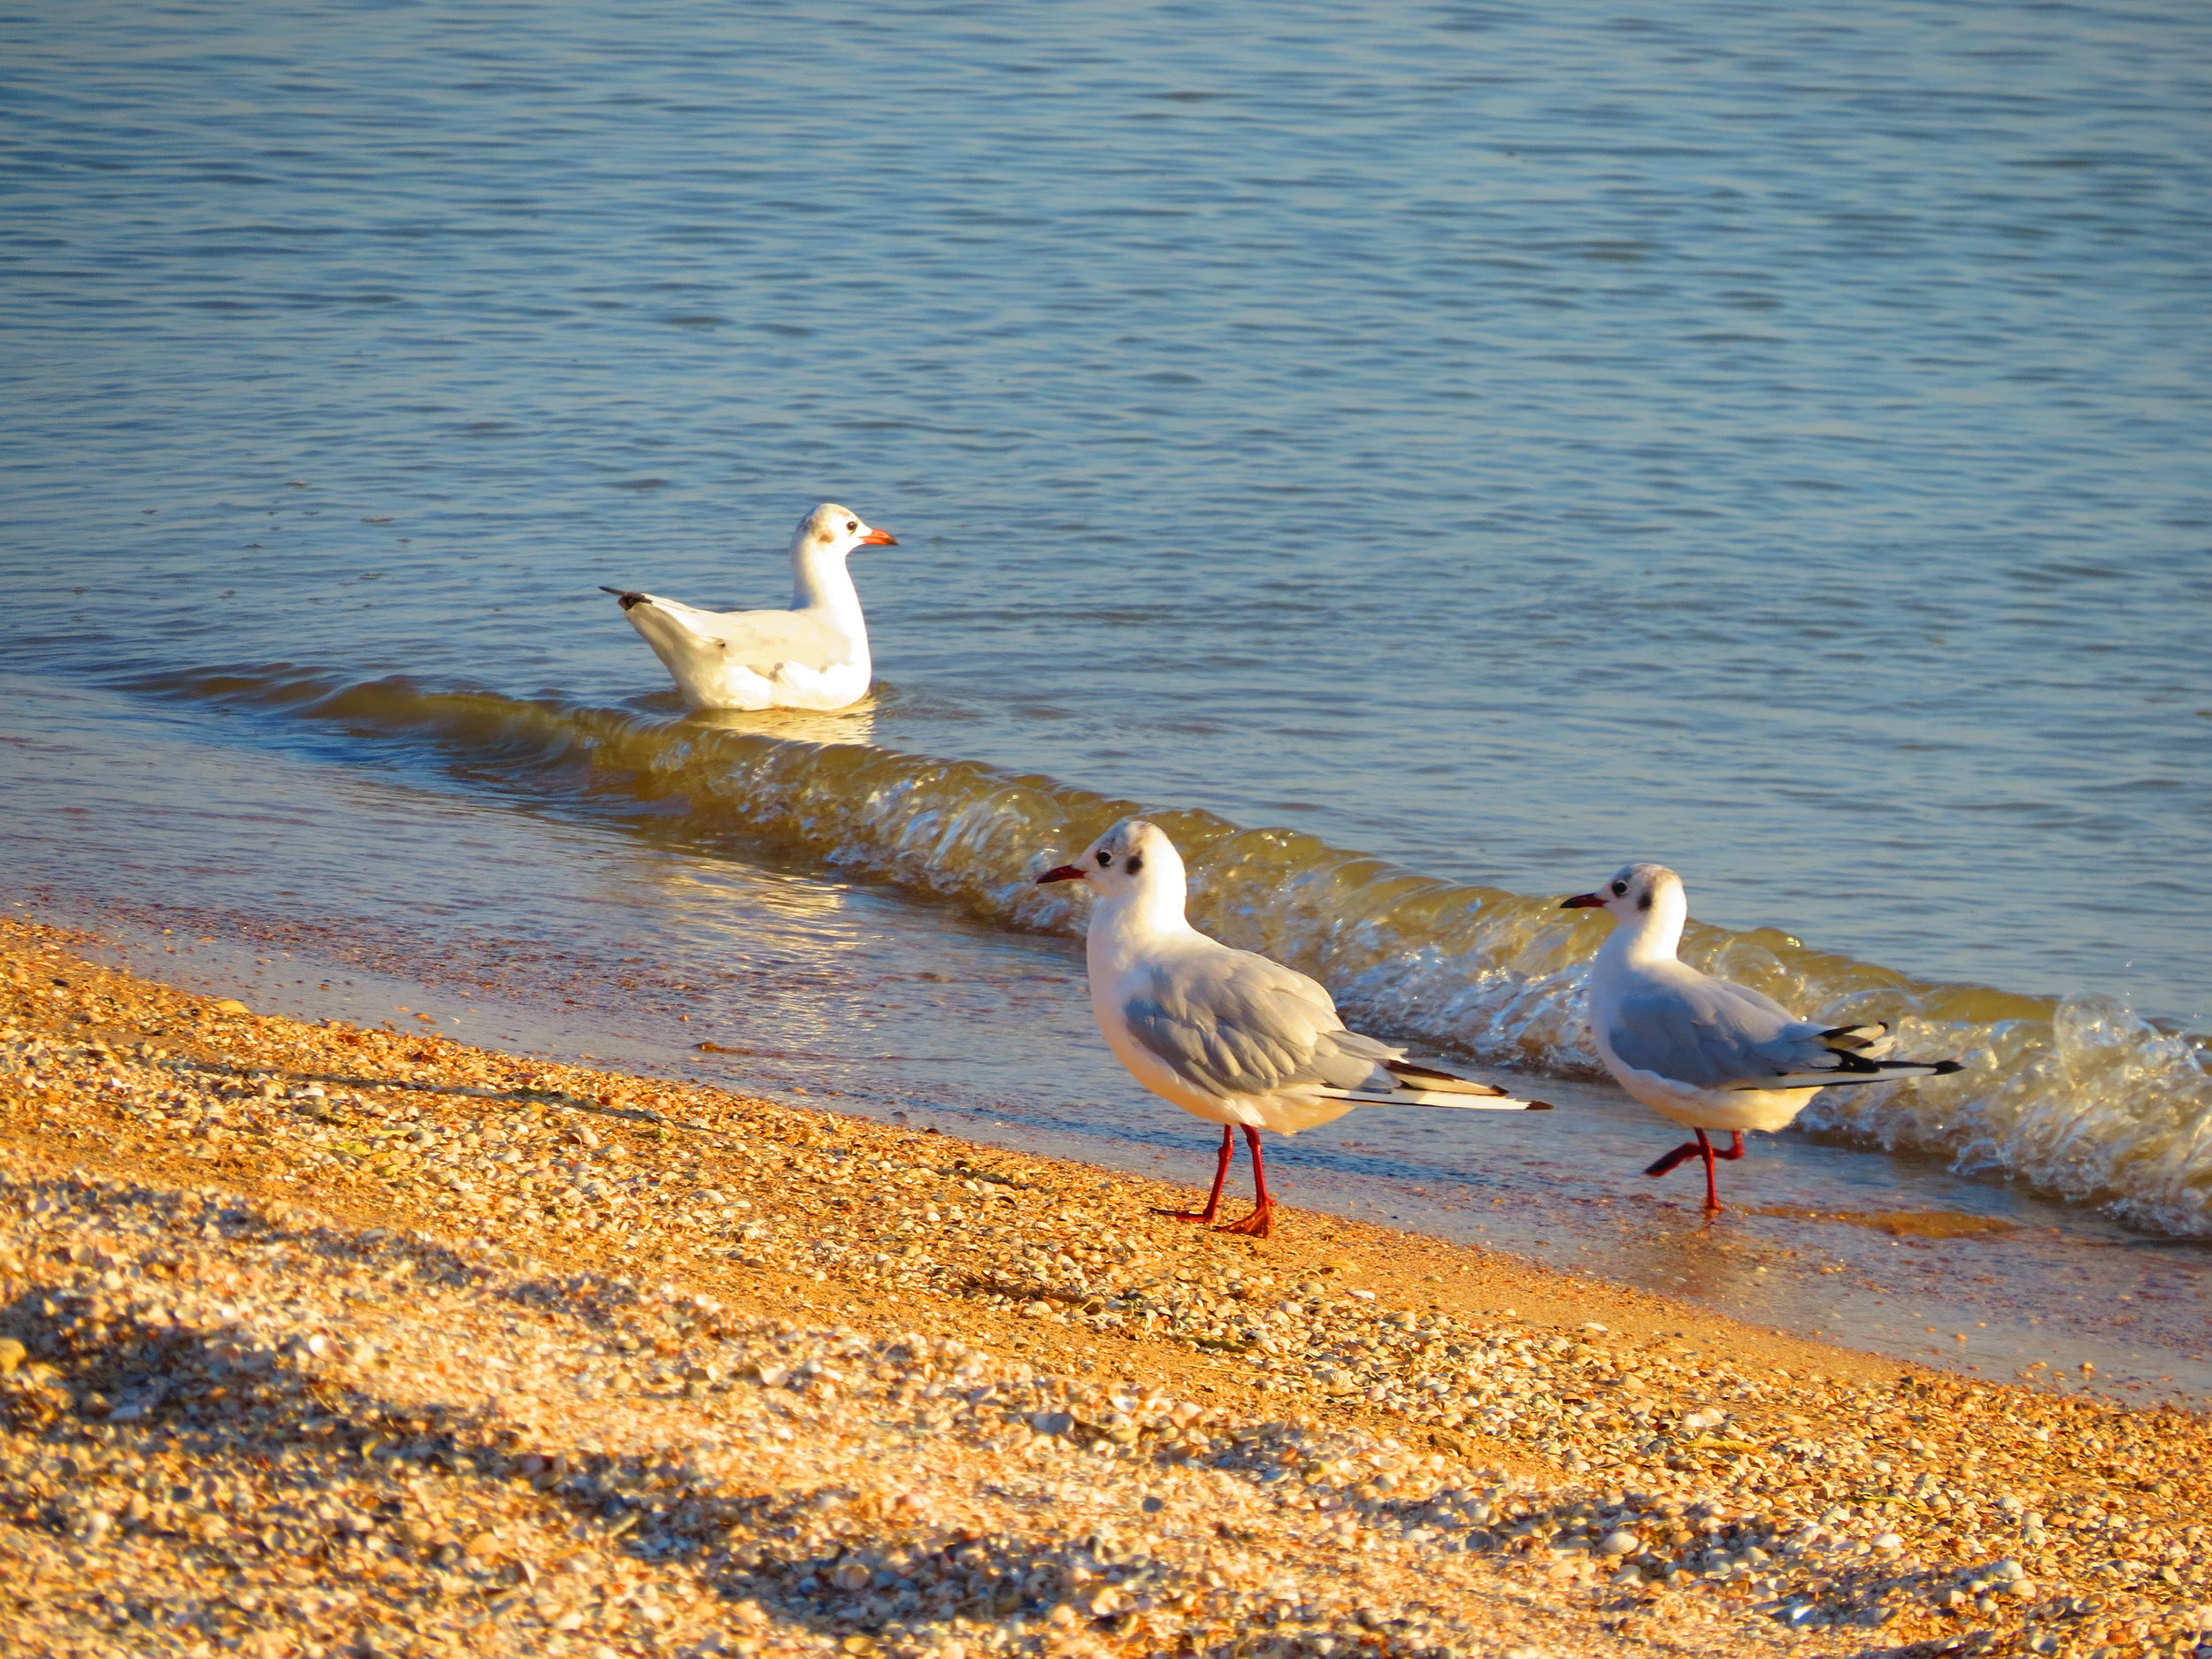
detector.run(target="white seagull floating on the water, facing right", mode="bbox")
[602,503,898,708]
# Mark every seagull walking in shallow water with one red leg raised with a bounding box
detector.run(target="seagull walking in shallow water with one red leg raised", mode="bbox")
[1560,865,1962,1217]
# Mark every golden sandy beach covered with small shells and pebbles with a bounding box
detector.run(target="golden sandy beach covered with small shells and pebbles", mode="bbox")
[0,923,2212,1659]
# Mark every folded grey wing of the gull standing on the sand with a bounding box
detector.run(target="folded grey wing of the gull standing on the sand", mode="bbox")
[1122,949,1401,1095]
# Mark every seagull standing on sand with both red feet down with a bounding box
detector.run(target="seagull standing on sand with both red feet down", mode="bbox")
[1038,818,1551,1239]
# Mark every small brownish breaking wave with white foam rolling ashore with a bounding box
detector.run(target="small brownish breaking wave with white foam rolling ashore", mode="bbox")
[131,666,2212,1237]
